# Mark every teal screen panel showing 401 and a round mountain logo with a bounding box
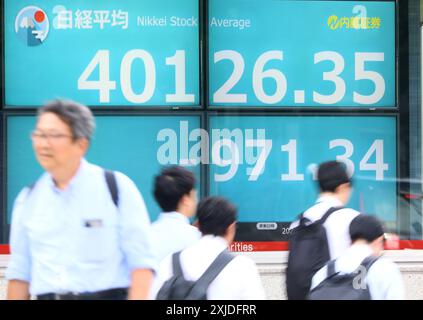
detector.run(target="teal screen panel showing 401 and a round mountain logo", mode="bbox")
[4,0,200,107]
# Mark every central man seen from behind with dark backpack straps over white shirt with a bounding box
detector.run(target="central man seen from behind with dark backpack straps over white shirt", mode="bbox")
[151,197,264,300]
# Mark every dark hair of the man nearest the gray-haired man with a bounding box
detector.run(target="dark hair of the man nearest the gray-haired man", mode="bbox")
[154,166,195,212]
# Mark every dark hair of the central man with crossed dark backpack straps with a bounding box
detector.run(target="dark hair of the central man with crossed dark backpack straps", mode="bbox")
[196,197,237,236]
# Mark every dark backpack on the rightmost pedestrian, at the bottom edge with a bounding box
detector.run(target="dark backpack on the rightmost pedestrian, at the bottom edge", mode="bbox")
[308,256,378,300]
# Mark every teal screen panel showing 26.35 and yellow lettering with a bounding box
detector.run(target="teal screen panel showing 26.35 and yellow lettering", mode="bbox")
[209,0,396,108]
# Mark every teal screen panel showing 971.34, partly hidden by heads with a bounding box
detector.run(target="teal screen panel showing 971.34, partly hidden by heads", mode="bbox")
[210,116,397,222]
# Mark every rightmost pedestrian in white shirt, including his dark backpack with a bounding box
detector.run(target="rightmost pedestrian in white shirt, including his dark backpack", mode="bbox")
[308,215,404,300]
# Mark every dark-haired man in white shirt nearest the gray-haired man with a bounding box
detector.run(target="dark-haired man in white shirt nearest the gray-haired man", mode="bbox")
[152,166,201,262]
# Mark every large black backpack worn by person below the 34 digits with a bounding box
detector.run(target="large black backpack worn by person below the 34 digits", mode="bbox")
[286,207,343,300]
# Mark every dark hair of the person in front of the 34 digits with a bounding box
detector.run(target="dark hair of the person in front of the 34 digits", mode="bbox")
[317,161,352,192]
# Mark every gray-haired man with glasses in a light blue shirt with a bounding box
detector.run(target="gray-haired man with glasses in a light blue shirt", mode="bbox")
[6,100,156,300]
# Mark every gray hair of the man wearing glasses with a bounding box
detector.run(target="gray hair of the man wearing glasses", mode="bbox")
[38,100,95,141]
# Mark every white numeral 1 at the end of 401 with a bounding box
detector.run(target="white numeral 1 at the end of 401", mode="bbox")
[166,50,195,102]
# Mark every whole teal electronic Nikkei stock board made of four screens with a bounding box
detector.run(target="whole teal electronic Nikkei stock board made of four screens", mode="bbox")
[4,0,398,250]
